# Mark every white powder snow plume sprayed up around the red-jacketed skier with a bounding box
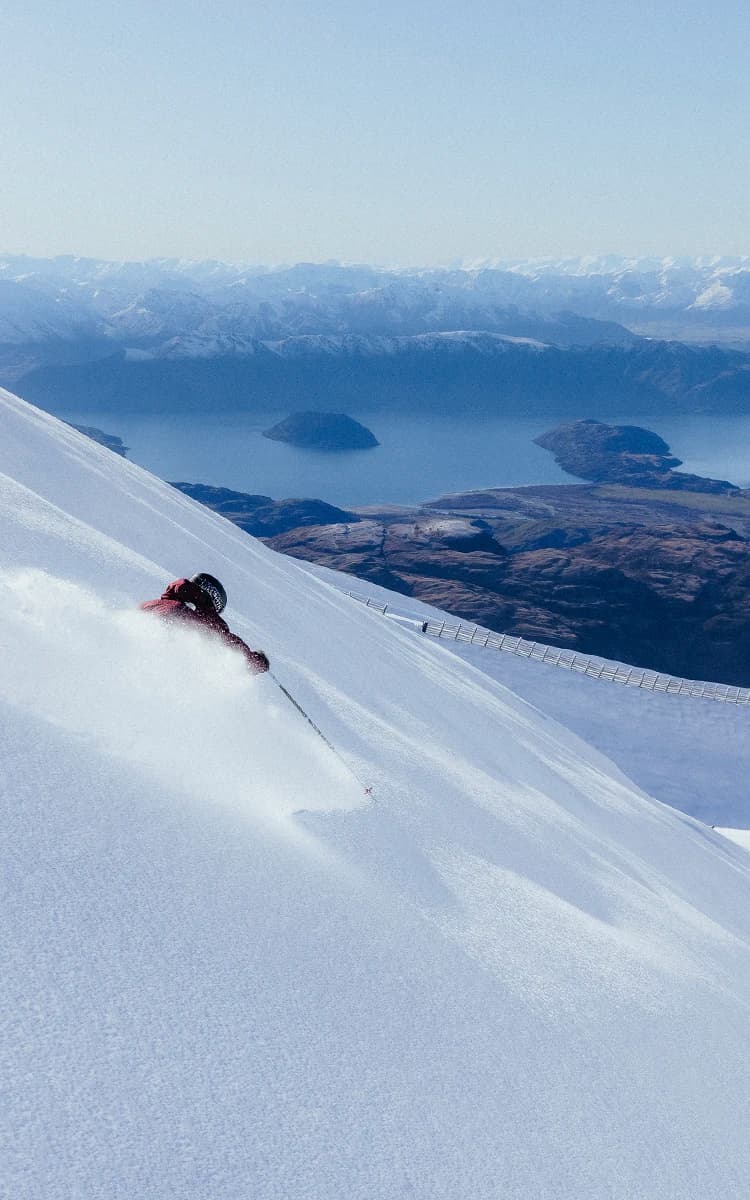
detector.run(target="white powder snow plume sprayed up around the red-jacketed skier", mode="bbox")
[0,570,358,829]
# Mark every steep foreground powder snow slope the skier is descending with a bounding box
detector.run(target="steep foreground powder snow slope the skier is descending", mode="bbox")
[0,394,750,1200]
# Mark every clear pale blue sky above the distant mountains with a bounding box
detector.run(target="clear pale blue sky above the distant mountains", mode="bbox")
[0,0,750,265]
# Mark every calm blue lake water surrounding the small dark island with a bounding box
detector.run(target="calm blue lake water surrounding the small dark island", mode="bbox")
[60,412,750,505]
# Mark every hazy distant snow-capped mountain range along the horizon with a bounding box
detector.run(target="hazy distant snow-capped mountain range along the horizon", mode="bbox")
[0,256,750,376]
